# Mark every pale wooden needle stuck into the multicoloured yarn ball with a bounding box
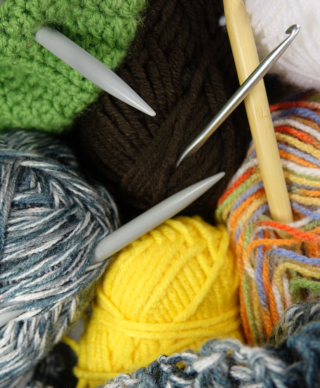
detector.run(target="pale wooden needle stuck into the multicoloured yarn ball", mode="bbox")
[223,0,293,223]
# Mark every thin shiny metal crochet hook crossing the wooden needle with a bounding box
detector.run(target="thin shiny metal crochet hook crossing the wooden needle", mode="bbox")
[176,24,300,168]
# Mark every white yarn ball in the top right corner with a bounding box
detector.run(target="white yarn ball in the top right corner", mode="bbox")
[245,0,320,90]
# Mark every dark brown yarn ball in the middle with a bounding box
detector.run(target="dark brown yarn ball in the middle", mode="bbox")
[73,0,251,218]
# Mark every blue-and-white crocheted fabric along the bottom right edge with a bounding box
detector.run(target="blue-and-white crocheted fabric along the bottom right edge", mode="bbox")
[87,302,320,388]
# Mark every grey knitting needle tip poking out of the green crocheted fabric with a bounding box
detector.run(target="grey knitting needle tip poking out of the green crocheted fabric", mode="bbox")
[34,27,156,116]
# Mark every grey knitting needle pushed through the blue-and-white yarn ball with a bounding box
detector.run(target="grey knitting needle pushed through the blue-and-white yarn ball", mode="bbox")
[0,172,225,327]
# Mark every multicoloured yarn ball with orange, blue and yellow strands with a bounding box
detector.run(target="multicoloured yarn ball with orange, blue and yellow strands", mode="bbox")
[216,93,320,344]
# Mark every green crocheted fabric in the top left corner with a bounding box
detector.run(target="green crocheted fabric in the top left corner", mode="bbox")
[0,0,145,132]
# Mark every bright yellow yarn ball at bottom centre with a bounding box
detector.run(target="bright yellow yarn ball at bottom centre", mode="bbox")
[74,217,242,388]
